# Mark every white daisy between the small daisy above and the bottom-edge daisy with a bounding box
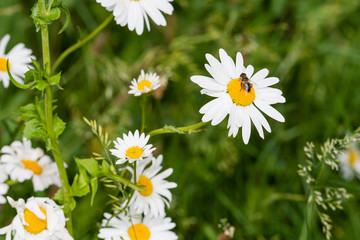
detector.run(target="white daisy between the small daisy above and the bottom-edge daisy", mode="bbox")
[128,155,177,217]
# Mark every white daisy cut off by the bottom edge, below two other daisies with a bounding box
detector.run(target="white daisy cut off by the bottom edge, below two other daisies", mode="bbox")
[98,208,178,240]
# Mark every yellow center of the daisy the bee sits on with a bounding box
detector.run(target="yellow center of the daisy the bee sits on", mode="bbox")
[227,78,255,106]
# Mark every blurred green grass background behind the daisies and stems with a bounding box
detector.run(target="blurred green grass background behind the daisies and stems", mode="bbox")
[0,0,360,240]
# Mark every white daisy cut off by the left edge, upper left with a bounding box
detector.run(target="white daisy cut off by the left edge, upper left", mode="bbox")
[0,34,35,88]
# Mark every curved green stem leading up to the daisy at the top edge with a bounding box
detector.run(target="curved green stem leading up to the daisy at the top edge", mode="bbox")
[51,14,114,73]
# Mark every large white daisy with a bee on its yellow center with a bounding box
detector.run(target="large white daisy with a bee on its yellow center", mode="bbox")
[191,49,285,144]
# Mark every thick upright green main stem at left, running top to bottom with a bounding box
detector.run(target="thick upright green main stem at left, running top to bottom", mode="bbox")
[38,0,72,235]
